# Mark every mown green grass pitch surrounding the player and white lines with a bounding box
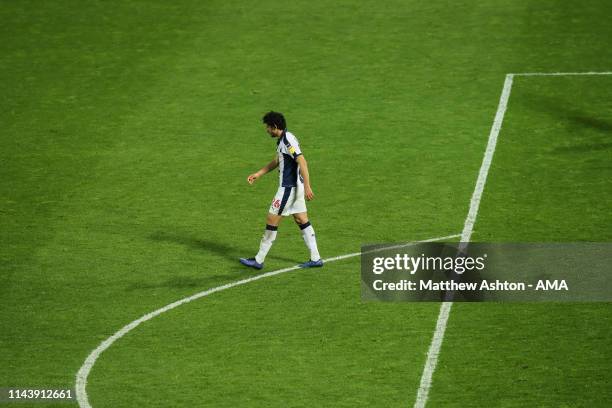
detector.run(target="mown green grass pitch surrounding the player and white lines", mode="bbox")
[0,0,612,408]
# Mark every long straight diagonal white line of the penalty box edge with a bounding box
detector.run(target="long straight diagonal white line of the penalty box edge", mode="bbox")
[414,74,514,408]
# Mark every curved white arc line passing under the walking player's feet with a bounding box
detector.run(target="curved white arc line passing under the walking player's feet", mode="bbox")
[75,234,460,408]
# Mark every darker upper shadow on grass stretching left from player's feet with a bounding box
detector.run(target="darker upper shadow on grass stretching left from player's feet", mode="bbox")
[149,232,296,265]
